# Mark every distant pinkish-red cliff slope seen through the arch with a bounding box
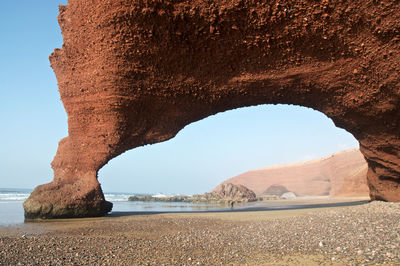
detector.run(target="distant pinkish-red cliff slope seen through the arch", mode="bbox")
[223,149,369,196]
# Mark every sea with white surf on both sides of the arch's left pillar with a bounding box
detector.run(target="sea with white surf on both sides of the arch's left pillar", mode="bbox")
[0,188,221,226]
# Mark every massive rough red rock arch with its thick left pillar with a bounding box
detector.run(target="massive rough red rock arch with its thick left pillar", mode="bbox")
[24,0,400,218]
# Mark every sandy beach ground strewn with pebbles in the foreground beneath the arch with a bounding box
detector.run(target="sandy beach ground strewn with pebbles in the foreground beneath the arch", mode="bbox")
[0,202,400,265]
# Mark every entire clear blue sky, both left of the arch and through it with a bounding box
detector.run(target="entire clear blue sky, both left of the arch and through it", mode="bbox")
[0,0,358,194]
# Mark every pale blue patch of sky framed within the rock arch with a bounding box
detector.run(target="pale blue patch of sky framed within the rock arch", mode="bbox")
[98,105,359,195]
